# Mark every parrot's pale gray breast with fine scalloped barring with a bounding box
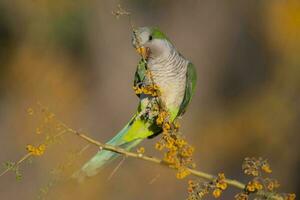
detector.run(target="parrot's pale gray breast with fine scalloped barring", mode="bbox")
[148,51,188,109]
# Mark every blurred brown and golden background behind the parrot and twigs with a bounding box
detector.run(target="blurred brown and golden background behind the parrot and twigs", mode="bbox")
[0,0,300,200]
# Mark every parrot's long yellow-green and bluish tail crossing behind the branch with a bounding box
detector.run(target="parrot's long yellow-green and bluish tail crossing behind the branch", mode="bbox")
[73,114,153,181]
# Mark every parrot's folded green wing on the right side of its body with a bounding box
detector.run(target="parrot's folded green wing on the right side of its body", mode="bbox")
[177,62,197,116]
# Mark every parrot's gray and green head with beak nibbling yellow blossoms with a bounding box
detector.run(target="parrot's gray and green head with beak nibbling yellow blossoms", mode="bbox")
[132,27,172,59]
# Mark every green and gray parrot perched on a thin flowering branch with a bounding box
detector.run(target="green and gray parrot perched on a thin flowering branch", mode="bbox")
[74,27,197,179]
